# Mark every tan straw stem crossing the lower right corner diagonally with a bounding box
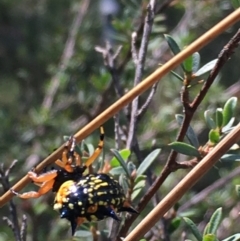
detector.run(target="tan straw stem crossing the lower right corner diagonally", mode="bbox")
[124,124,240,241]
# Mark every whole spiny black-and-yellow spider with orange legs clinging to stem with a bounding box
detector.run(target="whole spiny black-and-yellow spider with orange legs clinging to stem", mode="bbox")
[11,127,137,235]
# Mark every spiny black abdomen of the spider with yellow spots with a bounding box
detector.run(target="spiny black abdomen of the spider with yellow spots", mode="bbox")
[54,173,136,233]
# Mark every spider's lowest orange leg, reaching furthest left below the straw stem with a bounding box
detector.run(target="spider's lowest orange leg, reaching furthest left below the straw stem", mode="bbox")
[11,179,55,199]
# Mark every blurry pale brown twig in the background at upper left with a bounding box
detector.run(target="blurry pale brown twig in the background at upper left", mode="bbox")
[42,0,90,111]
